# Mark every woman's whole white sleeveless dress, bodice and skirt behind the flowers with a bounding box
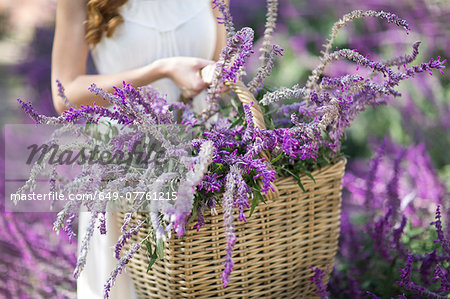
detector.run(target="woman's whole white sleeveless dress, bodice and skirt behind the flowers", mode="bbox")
[77,0,216,299]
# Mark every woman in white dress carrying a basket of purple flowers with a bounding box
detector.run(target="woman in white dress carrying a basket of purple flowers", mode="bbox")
[52,0,225,299]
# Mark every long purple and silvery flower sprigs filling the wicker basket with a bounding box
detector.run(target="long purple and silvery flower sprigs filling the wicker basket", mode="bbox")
[15,0,445,297]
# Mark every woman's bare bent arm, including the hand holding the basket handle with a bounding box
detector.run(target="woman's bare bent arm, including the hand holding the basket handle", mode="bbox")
[52,0,213,113]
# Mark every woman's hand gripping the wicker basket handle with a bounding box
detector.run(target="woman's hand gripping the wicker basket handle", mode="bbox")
[161,57,215,98]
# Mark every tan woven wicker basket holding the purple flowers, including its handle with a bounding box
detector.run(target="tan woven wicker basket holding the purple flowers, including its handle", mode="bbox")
[118,84,345,298]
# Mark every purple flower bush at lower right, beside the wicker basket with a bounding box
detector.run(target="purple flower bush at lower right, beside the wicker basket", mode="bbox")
[325,140,450,298]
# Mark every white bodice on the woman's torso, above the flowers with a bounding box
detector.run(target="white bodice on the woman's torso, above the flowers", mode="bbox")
[92,0,216,110]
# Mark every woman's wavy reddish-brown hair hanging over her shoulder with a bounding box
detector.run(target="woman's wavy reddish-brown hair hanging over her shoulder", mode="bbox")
[84,0,128,45]
